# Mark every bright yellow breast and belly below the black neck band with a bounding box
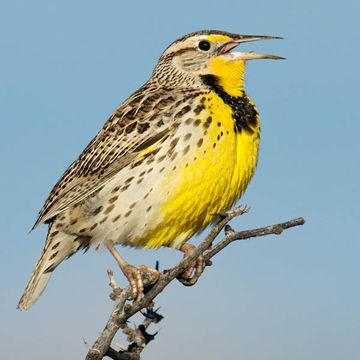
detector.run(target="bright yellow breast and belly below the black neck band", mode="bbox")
[139,92,260,247]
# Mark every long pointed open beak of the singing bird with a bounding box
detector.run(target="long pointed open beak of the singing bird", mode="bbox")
[219,35,285,60]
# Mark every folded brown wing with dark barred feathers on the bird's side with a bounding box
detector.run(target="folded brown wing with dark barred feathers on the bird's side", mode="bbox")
[34,87,177,228]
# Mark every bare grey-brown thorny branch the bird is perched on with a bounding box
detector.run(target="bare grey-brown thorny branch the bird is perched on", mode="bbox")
[86,207,305,360]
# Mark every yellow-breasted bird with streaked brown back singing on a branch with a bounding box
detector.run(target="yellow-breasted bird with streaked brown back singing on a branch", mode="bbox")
[18,30,283,310]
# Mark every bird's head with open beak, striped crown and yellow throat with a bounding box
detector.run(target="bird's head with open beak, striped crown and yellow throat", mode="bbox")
[153,30,283,96]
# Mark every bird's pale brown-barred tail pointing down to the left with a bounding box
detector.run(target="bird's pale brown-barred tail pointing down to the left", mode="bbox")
[17,234,83,310]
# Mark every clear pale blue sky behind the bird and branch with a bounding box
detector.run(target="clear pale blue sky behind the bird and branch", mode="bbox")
[0,0,360,360]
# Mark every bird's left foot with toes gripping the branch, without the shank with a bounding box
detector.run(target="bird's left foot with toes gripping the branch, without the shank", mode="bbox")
[121,264,159,301]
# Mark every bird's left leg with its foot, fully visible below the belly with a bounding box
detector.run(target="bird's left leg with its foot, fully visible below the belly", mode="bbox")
[106,244,159,301]
